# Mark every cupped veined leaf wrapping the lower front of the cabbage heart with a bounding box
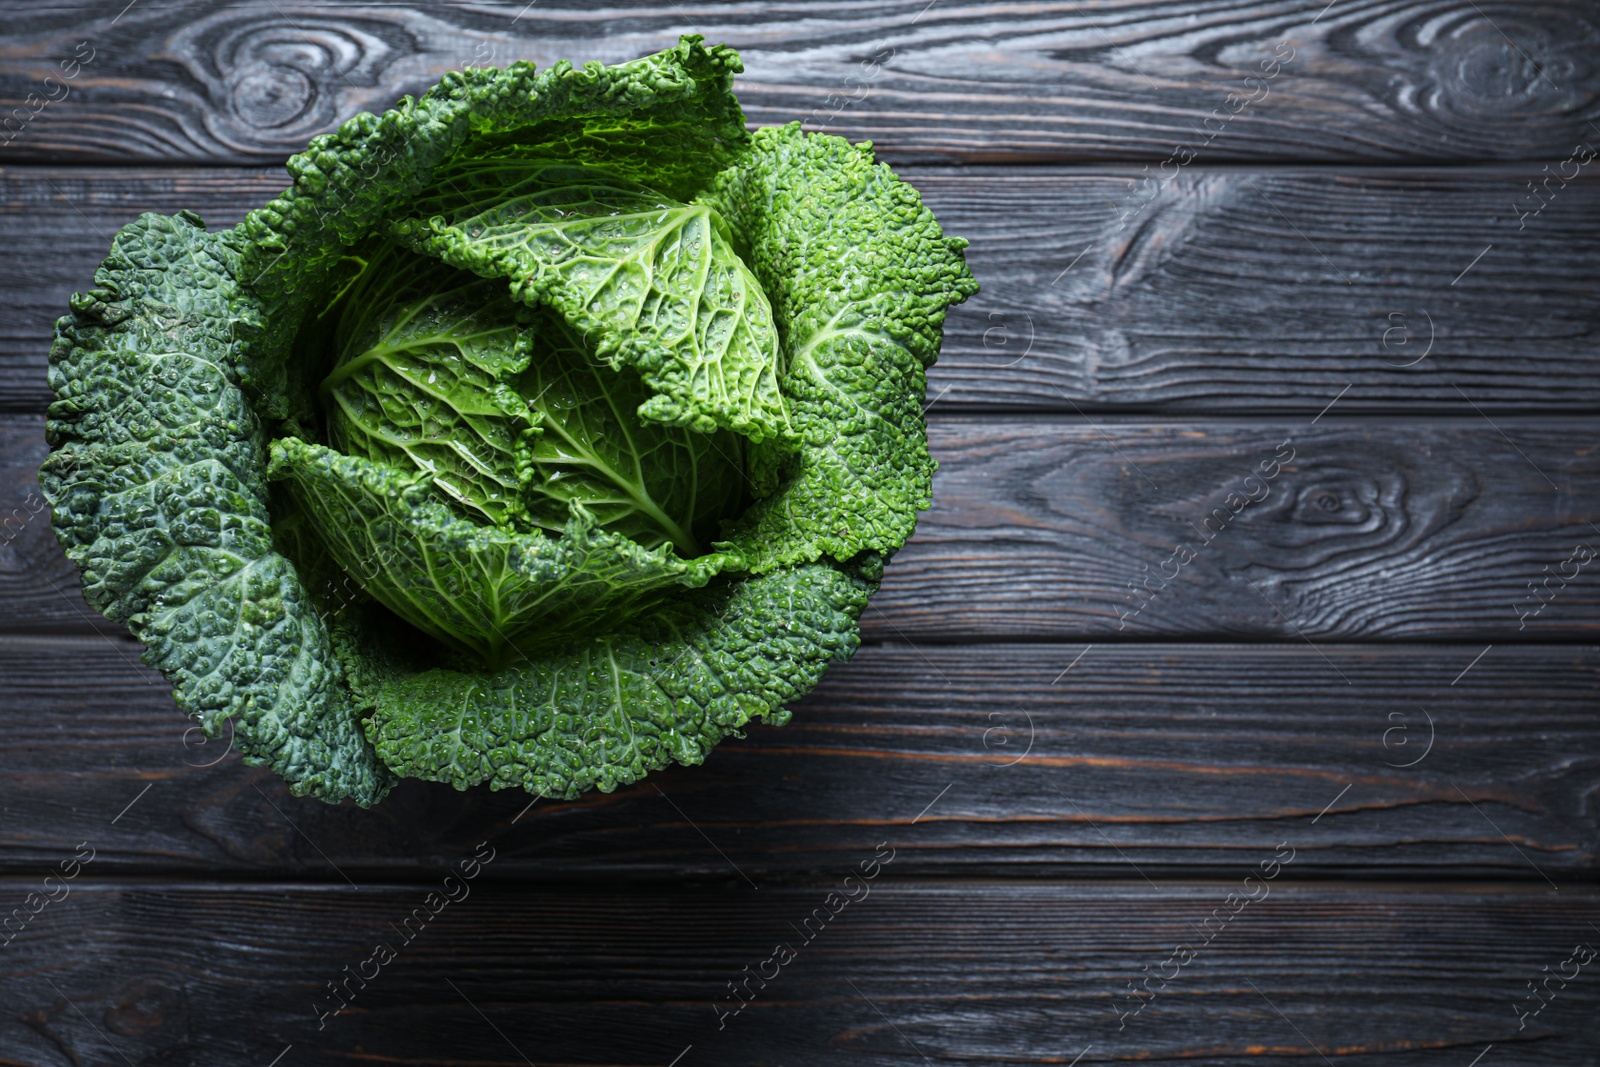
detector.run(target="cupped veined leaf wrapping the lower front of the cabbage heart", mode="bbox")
[267,437,739,665]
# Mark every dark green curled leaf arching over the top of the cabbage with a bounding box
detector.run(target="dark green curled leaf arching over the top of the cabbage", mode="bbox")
[237,35,749,426]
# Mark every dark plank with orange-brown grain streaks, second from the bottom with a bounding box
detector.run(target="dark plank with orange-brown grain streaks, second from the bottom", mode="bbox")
[0,638,1600,886]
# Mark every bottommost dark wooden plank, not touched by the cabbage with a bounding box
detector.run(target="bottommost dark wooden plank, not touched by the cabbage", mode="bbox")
[0,883,1600,1067]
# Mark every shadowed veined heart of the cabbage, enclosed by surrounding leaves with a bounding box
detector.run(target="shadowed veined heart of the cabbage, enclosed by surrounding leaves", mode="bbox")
[320,242,746,557]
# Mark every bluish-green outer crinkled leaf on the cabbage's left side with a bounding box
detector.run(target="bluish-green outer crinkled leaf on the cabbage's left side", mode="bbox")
[40,213,394,805]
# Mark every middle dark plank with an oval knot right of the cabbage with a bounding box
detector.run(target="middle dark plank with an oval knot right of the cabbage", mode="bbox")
[0,408,1600,643]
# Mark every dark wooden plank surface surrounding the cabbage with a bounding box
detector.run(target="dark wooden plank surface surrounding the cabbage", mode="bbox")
[0,0,1600,1067]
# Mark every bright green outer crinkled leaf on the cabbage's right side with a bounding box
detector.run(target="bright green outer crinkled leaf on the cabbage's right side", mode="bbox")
[702,123,978,573]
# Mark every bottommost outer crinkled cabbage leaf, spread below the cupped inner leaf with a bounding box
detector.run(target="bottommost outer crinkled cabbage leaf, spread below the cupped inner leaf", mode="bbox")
[358,563,875,798]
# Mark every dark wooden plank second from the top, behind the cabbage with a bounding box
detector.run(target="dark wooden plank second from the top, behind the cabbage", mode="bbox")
[0,165,1600,414]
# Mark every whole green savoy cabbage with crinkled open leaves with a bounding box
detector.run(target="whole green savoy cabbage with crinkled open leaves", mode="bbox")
[42,37,976,805]
